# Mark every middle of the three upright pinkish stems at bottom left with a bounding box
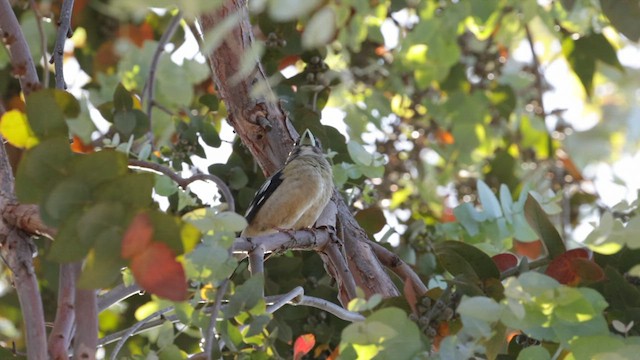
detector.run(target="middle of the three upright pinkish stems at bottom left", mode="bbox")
[49,263,80,360]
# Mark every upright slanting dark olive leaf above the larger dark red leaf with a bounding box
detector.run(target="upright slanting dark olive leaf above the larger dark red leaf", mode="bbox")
[524,195,567,259]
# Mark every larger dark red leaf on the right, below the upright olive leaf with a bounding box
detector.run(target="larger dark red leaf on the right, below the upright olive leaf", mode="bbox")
[545,248,604,286]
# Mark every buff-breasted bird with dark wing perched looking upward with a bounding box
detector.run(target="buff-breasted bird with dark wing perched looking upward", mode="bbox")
[242,130,333,236]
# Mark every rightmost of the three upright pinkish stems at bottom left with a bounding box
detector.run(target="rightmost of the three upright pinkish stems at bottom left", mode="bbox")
[73,287,98,360]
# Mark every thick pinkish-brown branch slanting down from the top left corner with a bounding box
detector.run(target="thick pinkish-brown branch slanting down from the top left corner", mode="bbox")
[0,0,41,95]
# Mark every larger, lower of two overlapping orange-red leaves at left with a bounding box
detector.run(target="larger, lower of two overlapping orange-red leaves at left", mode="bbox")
[131,242,189,301]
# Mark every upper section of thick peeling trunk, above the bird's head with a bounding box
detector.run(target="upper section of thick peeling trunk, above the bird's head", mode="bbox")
[200,0,298,175]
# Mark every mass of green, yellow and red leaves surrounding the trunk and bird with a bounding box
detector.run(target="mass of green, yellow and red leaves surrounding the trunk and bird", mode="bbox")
[0,0,640,359]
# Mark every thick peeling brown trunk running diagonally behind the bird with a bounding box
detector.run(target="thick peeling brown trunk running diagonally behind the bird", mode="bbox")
[200,0,399,304]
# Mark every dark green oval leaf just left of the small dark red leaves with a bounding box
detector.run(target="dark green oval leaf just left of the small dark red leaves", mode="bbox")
[434,240,500,280]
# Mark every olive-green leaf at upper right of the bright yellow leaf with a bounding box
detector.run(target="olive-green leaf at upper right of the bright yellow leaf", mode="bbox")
[26,89,70,142]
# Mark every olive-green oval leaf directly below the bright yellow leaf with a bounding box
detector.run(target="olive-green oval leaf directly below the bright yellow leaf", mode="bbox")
[16,137,73,203]
